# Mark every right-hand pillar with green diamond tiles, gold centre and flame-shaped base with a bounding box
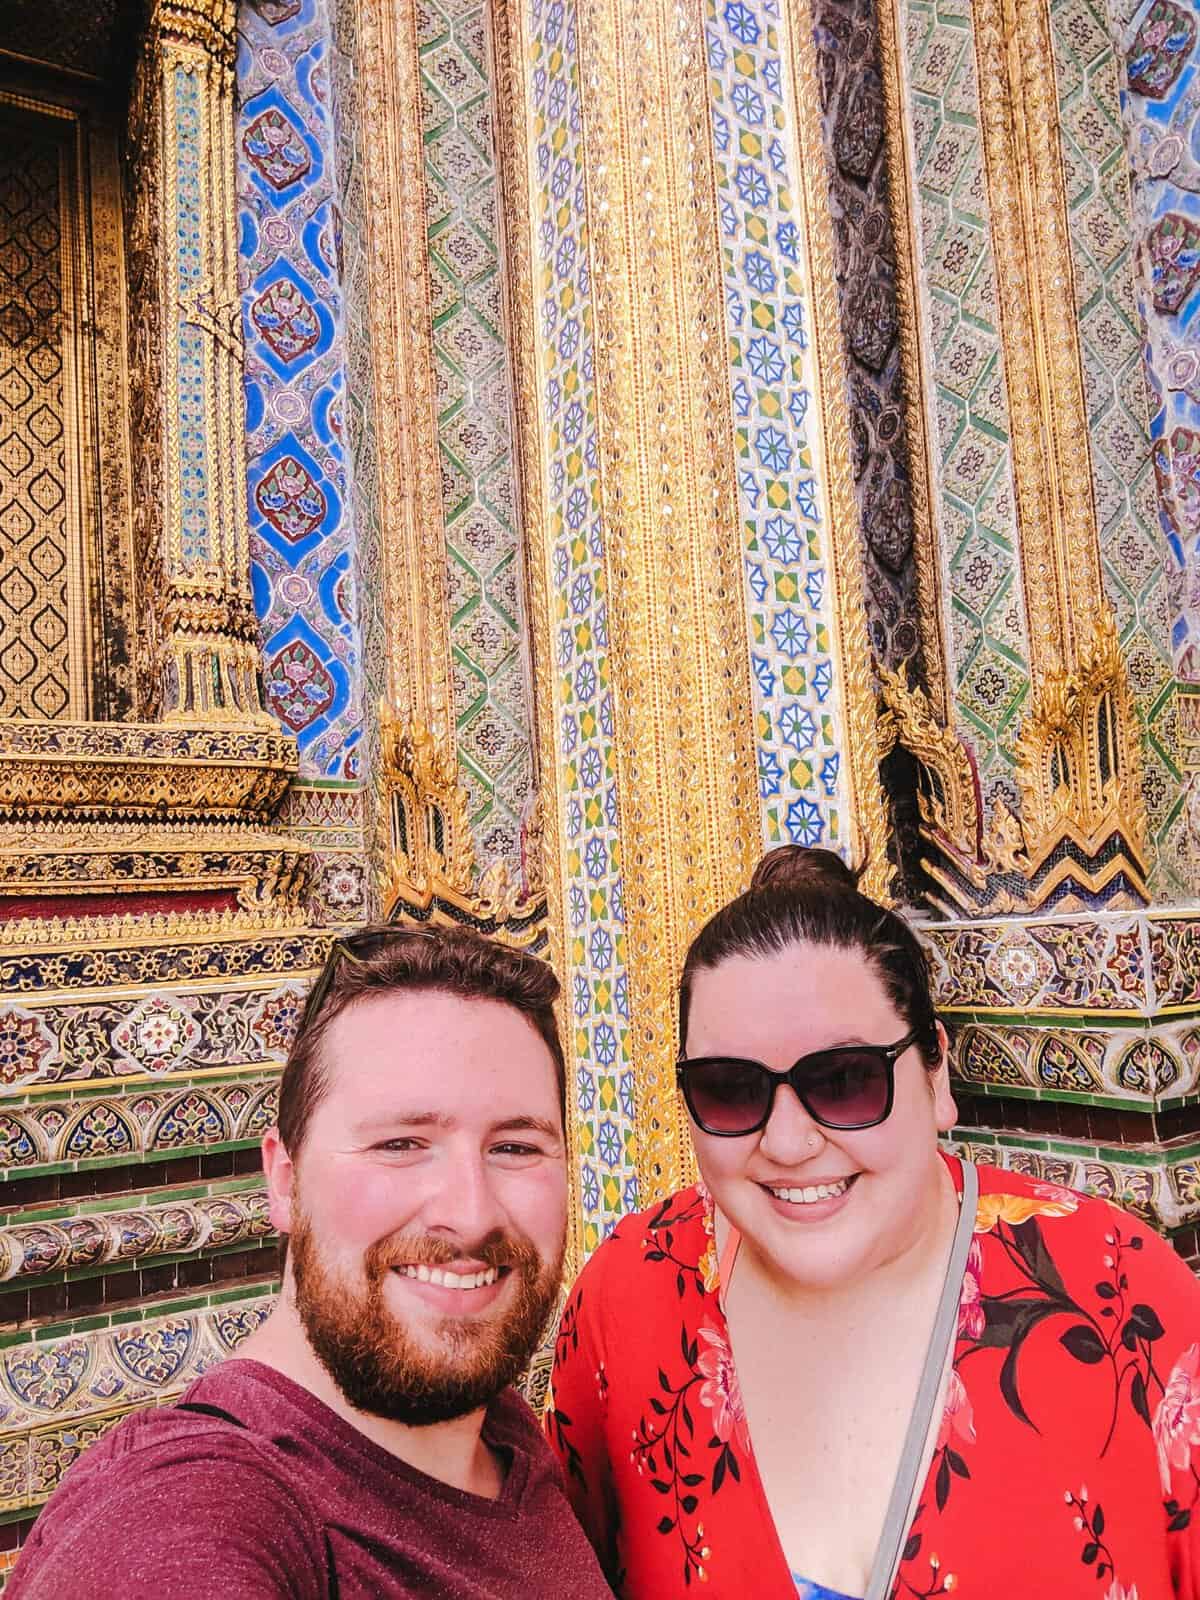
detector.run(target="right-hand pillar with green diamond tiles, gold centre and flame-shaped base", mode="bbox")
[880,0,1174,914]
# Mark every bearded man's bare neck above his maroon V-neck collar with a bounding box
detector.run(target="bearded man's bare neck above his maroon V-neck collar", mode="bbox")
[237,1291,504,1499]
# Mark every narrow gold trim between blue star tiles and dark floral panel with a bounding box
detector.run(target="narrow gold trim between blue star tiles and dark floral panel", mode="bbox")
[784,0,891,899]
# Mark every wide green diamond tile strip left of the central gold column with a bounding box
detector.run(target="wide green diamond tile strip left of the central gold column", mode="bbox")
[419,0,533,875]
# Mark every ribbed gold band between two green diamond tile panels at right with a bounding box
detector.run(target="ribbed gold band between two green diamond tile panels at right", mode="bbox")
[971,0,1104,685]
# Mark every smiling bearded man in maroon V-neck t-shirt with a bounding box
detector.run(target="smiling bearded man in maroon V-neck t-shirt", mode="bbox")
[8,928,610,1600]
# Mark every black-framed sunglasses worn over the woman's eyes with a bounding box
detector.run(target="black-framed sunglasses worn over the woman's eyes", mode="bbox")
[675,1029,920,1139]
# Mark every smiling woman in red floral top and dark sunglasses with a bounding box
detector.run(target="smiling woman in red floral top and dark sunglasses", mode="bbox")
[547,846,1200,1600]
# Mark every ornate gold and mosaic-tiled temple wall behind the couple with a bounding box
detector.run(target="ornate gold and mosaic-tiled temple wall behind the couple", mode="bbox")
[0,0,1200,1579]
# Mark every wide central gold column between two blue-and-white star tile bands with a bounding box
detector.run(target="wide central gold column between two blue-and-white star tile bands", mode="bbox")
[510,0,758,1203]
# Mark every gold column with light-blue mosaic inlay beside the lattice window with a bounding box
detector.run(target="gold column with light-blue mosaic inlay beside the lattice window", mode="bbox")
[130,0,273,726]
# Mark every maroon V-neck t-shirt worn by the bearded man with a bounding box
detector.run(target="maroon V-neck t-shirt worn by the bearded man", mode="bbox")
[14,1360,611,1600]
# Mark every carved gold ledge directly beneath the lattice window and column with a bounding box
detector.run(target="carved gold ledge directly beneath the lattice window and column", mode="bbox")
[0,718,298,822]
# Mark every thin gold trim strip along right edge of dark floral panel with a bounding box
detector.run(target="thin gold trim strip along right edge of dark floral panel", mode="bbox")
[877,0,950,723]
